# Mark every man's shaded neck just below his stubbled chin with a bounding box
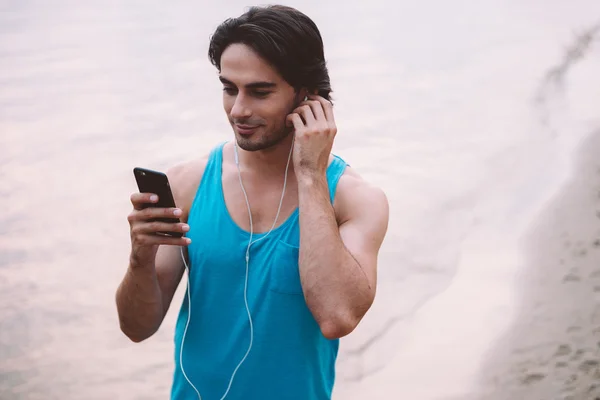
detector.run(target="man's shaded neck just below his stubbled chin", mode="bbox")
[237,134,294,176]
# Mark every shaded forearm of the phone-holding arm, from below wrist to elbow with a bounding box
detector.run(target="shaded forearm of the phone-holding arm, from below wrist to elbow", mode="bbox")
[116,265,164,342]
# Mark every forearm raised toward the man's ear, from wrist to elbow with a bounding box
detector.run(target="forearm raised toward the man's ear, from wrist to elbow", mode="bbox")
[298,176,372,337]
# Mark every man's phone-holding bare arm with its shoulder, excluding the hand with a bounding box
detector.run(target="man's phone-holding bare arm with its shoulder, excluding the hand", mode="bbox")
[116,159,206,342]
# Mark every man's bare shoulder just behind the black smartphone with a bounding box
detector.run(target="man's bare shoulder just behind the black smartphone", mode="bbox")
[166,154,209,221]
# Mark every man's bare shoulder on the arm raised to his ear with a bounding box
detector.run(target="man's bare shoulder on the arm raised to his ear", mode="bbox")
[334,167,389,231]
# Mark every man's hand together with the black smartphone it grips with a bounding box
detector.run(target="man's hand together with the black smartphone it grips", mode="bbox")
[128,167,191,264]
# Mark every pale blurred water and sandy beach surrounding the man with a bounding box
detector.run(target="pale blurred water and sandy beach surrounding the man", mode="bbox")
[0,0,600,400]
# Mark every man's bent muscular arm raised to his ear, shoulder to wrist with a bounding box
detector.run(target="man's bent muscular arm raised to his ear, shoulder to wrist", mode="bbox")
[298,172,389,339]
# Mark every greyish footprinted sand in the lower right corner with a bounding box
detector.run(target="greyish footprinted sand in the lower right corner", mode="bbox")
[476,130,600,400]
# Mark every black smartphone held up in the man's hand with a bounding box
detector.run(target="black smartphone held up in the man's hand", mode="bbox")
[133,167,183,237]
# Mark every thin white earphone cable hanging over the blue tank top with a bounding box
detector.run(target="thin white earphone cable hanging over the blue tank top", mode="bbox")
[179,137,294,400]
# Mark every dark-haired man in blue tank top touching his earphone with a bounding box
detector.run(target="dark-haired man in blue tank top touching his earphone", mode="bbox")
[116,6,388,400]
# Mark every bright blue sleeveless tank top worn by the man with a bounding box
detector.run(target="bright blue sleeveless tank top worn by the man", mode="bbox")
[171,143,347,400]
